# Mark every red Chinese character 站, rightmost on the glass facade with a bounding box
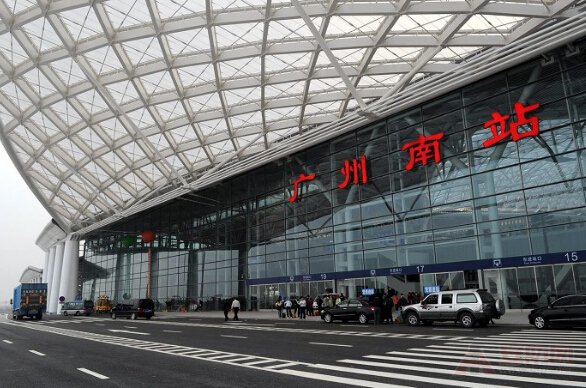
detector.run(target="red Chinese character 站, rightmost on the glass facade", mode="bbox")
[482,102,541,148]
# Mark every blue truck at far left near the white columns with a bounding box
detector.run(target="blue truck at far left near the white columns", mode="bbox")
[12,283,47,320]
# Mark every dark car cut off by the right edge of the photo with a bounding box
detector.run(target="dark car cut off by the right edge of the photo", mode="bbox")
[529,295,586,329]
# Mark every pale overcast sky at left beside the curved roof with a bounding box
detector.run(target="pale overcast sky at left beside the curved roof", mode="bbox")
[0,144,51,306]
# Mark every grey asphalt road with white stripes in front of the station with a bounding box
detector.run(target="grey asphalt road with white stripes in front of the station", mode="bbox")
[0,313,586,388]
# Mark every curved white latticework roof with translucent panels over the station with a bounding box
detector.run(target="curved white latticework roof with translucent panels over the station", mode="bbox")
[0,0,584,231]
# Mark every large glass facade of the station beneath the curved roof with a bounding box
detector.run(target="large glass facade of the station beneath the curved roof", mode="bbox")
[80,38,586,308]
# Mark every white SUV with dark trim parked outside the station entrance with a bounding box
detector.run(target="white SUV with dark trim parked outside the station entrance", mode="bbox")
[401,289,505,328]
